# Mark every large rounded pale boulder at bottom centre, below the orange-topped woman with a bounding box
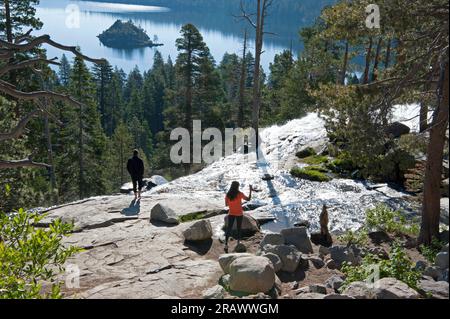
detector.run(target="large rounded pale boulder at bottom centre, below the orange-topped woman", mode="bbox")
[230,256,275,294]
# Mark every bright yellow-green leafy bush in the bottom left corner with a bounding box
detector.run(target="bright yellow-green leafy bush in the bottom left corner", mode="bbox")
[0,209,80,299]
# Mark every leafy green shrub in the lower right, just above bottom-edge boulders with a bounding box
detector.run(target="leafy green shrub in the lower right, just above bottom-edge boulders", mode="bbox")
[340,244,422,290]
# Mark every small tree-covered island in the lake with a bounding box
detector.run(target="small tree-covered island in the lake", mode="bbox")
[98,20,162,49]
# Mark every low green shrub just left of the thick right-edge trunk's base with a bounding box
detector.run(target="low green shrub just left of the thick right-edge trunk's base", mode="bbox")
[366,204,420,236]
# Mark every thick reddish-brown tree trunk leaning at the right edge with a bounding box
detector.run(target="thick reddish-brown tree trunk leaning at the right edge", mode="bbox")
[418,61,449,245]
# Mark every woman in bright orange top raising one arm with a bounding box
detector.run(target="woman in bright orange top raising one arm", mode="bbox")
[225,182,253,253]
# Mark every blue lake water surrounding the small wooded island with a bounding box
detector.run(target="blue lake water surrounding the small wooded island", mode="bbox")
[35,0,326,72]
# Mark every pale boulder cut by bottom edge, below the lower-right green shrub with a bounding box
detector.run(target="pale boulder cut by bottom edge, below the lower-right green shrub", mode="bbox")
[375,278,420,299]
